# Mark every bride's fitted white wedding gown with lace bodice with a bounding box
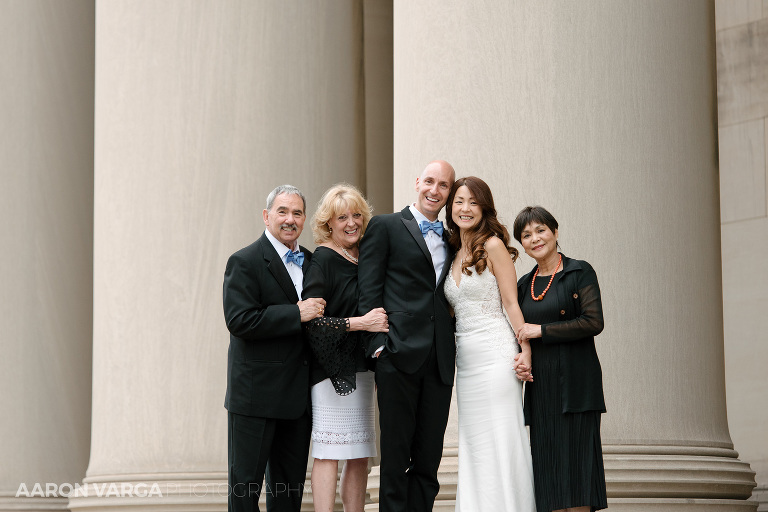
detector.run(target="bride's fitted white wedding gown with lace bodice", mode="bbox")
[445,267,536,512]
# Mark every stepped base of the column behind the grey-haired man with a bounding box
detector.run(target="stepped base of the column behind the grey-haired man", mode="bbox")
[67,472,314,512]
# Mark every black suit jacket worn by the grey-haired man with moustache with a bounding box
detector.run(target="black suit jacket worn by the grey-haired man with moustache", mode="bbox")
[224,234,312,419]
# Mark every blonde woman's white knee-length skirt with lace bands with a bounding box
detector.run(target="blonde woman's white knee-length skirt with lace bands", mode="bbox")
[312,372,376,460]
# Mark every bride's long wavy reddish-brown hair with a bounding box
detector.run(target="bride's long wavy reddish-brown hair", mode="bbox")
[445,176,519,276]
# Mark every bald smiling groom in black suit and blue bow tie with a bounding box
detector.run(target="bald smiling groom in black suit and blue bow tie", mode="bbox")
[358,161,456,512]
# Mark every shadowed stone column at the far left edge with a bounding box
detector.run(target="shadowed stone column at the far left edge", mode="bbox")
[0,0,94,511]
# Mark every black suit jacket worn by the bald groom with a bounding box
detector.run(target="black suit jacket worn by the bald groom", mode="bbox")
[358,207,456,385]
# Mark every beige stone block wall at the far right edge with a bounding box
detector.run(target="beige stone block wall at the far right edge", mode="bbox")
[716,0,768,511]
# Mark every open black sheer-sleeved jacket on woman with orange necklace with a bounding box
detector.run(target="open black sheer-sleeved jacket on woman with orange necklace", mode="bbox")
[517,256,605,423]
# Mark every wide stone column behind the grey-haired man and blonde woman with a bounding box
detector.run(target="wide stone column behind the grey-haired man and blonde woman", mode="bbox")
[69,0,364,510]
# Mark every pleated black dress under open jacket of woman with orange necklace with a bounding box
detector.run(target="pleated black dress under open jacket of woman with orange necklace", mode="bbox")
[520,272,608,512]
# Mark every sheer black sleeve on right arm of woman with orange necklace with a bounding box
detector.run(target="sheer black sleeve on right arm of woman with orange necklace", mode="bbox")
[541,265,603,343]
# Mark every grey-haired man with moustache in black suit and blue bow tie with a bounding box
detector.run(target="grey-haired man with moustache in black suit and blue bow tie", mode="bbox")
[224,185,325,512]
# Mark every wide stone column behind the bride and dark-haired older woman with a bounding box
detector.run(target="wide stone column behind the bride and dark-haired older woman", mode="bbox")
[380,0,755,511]
